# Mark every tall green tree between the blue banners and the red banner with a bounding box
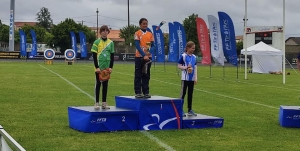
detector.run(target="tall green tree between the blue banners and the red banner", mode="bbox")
[183,14,200,55]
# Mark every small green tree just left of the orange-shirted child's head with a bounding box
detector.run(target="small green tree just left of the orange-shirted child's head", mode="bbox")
[120,25,140,45]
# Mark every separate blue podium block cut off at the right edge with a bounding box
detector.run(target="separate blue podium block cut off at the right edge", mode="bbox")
[279,106,300,128]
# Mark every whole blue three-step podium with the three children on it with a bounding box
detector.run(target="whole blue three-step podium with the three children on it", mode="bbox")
[68,96,224,133]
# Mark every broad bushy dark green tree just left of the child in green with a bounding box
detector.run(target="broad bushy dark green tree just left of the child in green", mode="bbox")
[47,18,96,53]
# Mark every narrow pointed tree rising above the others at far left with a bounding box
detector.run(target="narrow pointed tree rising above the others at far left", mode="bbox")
[36,7,53,31]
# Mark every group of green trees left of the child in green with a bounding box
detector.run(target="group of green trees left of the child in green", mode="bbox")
[0,7,96,52]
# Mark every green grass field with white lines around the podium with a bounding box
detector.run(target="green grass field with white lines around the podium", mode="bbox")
[0,61,300,151]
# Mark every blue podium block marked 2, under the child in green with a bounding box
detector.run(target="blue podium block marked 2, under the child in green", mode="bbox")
[68,106,138,133]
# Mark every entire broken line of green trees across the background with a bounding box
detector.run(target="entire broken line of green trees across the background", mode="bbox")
[0,7,243,55]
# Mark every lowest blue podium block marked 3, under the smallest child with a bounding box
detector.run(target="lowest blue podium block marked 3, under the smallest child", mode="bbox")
[182,114,224,129]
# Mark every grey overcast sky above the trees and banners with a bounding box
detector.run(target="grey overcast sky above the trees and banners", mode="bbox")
[0,0,300,37]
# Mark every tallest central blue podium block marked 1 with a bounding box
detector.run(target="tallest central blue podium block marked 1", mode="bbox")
[115,96,182,130]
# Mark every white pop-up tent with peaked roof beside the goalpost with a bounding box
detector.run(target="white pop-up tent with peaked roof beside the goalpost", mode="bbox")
[241,42,283,73]
